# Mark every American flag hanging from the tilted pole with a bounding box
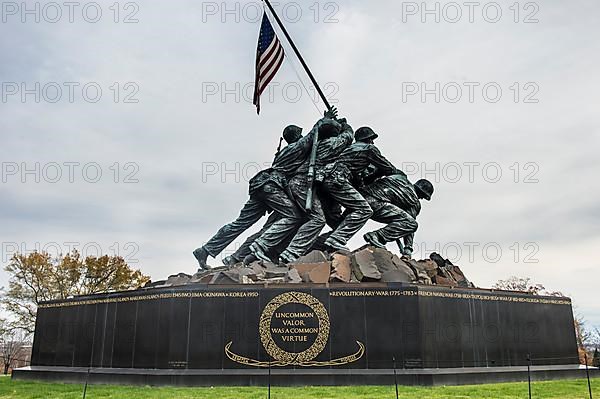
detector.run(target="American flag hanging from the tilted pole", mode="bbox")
[253,11,285,114]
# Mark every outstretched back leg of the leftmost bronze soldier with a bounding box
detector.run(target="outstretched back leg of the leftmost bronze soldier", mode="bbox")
[194,196,267,268]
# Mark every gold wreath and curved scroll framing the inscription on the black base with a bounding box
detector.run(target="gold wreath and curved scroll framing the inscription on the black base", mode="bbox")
[225,291,365,367]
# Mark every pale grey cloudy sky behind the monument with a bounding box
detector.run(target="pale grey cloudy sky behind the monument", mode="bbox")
[0,0,600,325]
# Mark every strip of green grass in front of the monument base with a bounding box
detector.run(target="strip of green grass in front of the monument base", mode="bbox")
[0,377,600,399]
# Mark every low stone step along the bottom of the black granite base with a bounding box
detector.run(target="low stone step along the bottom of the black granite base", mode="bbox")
[13,365,600,387]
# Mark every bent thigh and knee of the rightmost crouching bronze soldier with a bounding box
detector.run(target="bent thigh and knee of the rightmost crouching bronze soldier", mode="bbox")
[367,202,419,243]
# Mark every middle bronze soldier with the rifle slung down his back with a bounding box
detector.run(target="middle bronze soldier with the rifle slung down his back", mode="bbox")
[280,119,354,263]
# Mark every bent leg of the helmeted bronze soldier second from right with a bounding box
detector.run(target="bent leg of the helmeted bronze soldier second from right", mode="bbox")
[324,178,373,248]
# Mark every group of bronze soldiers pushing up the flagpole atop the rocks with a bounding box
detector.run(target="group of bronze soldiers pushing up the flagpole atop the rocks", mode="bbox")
[193,108,433,271]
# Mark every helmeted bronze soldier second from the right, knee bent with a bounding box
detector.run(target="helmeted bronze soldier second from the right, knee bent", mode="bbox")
[319,127,397,249]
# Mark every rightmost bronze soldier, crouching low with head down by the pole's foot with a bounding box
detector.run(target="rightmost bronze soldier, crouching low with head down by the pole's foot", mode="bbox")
[361,173,433,257]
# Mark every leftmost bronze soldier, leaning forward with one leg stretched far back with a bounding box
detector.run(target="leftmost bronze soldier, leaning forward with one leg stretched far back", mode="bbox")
[194,125,316,269]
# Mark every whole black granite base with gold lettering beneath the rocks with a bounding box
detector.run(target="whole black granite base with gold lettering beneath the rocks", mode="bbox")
[24,283,579,385]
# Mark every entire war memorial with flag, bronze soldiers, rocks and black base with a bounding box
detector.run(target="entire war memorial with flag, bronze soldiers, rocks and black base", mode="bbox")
[14,1,578,386]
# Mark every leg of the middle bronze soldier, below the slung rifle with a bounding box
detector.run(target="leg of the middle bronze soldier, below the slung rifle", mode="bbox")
[281,180,325,263]
